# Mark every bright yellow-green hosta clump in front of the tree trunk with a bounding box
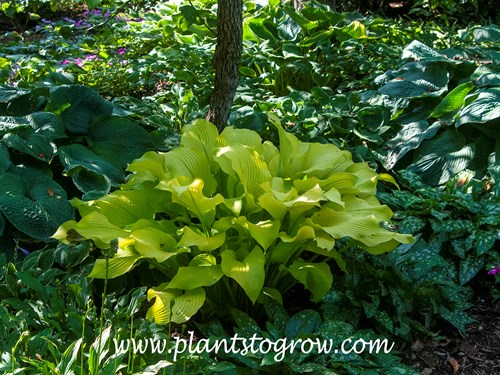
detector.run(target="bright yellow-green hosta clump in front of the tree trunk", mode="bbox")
[50,116,412,324]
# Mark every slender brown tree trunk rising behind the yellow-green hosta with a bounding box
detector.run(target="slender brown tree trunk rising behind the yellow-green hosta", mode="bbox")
[207,0,243,131]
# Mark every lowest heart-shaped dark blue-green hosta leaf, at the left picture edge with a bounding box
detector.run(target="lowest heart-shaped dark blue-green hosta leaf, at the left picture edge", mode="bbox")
[0,173,73,241]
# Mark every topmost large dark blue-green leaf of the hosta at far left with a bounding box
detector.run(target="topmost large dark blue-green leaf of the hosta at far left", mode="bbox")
[45,85,113,134]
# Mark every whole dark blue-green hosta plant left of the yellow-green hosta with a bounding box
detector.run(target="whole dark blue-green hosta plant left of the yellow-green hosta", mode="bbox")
[0,86,153,241]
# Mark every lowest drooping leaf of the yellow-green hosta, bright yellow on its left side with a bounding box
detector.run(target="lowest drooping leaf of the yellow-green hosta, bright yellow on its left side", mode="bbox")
[146,283,205,324]
